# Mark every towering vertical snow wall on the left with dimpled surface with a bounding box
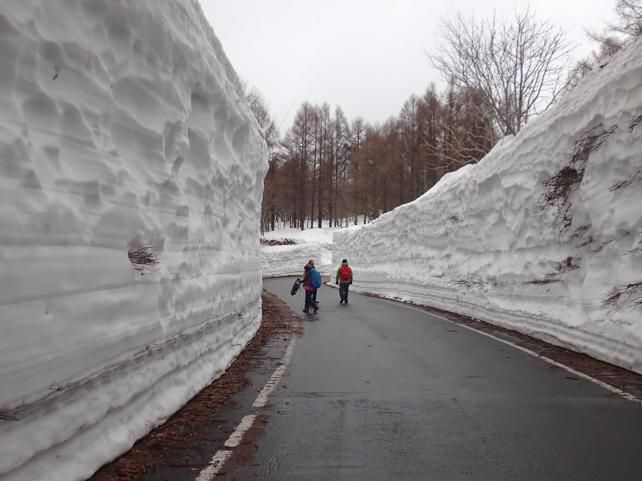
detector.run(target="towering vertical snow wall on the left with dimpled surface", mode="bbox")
[0,0,266,481]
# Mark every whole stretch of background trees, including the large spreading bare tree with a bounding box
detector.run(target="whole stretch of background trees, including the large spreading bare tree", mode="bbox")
[247,0,642,232]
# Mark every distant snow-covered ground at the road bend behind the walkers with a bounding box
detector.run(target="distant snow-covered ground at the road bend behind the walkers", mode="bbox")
[261,226,339,277]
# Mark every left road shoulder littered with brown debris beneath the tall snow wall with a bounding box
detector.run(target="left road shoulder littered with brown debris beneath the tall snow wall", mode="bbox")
[90,291,301,481]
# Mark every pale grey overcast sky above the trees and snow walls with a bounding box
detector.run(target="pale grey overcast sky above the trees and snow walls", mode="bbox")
[200,0,615,127]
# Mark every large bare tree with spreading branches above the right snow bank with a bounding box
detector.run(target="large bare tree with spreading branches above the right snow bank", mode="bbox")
[430,9,569,134]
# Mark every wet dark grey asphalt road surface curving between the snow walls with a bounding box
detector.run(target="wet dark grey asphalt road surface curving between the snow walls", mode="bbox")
[229,279,642,481]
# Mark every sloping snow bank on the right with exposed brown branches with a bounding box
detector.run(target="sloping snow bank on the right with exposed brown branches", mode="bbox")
[334,41,642,373]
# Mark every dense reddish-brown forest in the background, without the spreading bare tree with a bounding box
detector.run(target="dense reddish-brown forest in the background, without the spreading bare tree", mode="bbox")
[255,83,495,230]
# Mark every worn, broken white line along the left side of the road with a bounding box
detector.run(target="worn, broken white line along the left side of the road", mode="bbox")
[196,336,296,481]
